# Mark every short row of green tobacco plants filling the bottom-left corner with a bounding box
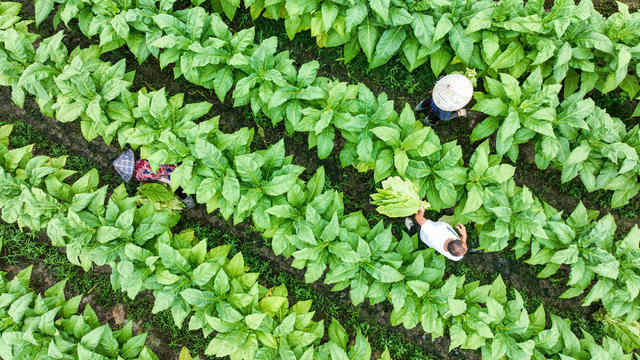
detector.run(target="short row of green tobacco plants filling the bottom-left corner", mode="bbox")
[0,266,158,360]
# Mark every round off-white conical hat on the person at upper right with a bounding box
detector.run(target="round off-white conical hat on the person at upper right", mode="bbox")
[431,74,473,111]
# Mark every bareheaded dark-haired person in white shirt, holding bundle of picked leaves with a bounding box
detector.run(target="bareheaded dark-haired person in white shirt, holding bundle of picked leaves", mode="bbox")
[404,205,467,261]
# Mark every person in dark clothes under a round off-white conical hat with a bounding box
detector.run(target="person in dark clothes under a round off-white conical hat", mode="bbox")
[415,74,473,126]
